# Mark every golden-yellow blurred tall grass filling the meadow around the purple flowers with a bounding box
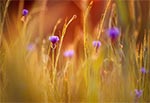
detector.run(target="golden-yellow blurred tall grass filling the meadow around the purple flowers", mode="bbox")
[0,0,150,103]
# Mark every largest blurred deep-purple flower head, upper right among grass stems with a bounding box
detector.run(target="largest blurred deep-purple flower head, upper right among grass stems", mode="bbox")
[107,27,120,41]
